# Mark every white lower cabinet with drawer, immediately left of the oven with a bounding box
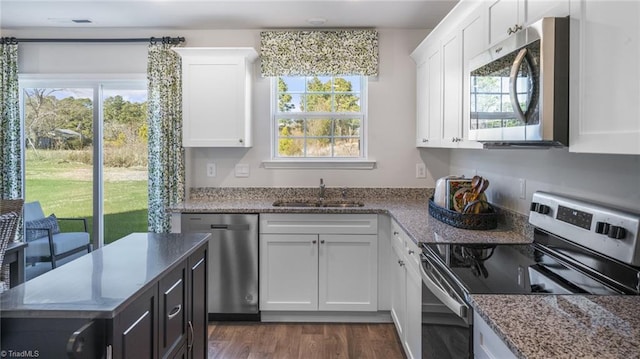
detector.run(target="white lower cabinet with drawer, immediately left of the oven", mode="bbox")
[391,222,422,359]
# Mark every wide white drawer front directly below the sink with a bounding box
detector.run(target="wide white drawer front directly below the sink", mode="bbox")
[260,214,378,234]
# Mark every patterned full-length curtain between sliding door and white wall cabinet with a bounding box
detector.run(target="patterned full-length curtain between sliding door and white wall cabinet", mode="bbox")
[147,44,184,233]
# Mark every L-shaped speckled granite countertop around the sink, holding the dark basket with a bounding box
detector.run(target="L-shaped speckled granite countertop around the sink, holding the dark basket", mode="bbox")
[171,188,533,244]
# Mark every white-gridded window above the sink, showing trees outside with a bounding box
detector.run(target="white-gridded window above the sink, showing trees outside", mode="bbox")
[273,76,366,160]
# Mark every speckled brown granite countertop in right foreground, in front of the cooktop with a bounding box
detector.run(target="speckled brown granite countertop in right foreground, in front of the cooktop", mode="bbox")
[471,295,640,359]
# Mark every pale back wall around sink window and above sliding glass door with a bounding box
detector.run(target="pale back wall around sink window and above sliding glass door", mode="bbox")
[3,29,449,187]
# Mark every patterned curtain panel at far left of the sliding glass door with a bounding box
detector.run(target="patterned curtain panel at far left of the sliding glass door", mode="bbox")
[0,38,22,199]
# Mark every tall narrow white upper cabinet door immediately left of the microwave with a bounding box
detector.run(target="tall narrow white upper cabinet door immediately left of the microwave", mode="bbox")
[442,31,462,147]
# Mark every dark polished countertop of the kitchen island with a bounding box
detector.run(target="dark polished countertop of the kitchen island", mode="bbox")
[0,233,210,319]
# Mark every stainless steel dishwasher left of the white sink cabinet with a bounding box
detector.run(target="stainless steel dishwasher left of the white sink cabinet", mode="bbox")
[181,213,260,320]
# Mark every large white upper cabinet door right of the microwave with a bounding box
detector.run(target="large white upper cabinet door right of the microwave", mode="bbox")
[569,0,640,155]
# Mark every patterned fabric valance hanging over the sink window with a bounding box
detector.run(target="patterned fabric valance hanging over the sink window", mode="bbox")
[260,30,378,77]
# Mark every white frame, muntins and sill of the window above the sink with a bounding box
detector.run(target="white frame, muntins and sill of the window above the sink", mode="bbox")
[270,75,375,163]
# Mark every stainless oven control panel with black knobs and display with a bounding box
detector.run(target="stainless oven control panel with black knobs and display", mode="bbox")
[529,192,640,267]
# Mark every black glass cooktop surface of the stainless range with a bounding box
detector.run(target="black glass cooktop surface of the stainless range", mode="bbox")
[423,230,640,294]
